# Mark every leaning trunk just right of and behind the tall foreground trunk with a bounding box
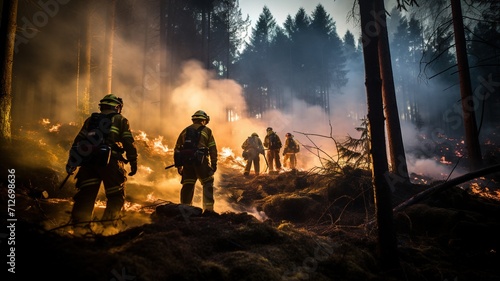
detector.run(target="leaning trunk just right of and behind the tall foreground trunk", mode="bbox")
[373,0,410,183]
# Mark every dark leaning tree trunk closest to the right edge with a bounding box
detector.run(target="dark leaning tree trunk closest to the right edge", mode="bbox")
[451,0,483,171]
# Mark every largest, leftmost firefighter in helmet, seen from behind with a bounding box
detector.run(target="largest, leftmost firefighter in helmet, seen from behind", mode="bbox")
[66,94,138,234]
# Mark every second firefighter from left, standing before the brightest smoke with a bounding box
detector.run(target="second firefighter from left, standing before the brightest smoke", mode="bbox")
[174,110,218,214]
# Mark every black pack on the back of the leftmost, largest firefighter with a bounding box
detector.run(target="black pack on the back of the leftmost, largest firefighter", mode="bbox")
[70,112,118,167]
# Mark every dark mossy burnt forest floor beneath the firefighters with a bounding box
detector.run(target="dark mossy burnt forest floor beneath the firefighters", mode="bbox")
[0,129,500,281]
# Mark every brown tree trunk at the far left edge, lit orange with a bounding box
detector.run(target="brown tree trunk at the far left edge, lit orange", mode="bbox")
[0,0,18,143]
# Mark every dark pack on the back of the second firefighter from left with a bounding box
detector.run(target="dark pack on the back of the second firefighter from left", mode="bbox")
[174,126,208,167]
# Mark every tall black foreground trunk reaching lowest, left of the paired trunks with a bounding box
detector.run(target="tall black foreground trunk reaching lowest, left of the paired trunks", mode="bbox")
[359,0,399,270]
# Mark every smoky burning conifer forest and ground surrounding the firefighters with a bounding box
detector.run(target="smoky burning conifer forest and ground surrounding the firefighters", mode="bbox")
[0,0,500,280]
